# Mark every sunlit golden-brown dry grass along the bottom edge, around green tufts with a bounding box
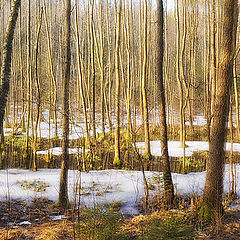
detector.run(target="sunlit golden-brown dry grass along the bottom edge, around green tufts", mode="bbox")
[0,205,240,240]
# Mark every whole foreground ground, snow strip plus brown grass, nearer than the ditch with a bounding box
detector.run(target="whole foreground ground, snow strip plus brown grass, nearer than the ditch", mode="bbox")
[0,167,240,240]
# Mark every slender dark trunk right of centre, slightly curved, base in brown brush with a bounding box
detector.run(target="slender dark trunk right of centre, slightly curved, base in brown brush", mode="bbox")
[156,0,174,204]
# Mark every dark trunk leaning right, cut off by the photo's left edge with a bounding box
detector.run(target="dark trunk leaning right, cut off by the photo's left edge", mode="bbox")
[0,0,21,145]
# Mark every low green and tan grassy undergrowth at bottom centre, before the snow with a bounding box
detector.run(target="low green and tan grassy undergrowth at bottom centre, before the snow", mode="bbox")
[76,206,197,240]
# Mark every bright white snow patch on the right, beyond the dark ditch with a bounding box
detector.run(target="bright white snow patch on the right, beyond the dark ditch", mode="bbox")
[136,141,240,157]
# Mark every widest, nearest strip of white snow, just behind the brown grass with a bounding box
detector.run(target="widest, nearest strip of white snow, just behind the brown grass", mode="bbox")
[0,165,240,215]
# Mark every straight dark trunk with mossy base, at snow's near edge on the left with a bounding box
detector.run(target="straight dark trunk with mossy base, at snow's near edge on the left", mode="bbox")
[59,0,71,208]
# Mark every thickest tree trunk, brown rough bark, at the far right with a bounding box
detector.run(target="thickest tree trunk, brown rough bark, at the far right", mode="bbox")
[203,0,238,220]
